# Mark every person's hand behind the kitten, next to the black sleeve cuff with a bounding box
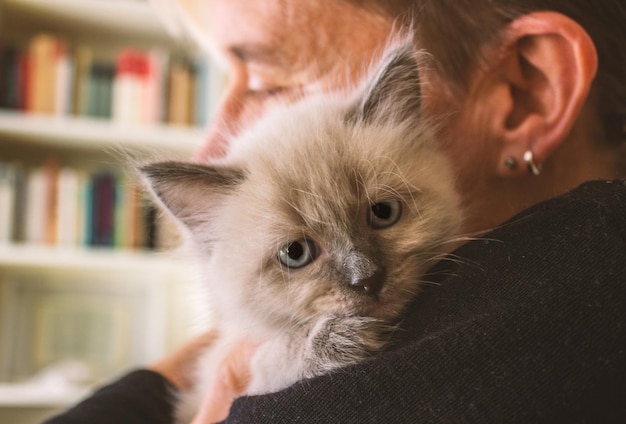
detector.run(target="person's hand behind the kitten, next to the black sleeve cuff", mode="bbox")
[148,331,217,391]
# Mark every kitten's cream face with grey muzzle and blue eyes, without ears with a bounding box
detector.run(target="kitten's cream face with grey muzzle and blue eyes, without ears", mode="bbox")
[222,111,459,319]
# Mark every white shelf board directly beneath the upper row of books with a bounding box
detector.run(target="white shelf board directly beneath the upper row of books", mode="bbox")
[0,111,205,156]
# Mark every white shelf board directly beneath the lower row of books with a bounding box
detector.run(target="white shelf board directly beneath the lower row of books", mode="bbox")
[0,244,190,273]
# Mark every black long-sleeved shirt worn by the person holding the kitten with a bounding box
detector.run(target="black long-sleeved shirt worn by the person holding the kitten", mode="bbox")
[49,181,626,424]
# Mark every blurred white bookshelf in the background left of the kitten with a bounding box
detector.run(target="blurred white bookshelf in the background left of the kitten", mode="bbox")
[0,0,217,424]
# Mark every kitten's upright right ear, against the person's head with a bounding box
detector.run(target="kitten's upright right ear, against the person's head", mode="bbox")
[348,40,421,123]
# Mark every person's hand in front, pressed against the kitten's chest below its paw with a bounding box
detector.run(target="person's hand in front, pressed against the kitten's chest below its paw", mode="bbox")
[191,342,260,424]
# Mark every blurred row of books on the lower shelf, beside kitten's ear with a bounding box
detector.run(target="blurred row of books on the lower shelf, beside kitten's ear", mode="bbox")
[0,159,159,249]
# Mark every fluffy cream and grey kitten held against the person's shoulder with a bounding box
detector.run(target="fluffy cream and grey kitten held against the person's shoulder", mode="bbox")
[141,43,460,422]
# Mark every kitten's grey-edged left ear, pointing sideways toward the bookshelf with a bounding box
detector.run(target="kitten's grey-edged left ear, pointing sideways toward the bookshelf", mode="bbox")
[139,162,246,229]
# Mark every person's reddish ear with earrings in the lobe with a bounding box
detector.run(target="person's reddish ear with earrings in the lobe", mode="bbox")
[487,12,598,176]
